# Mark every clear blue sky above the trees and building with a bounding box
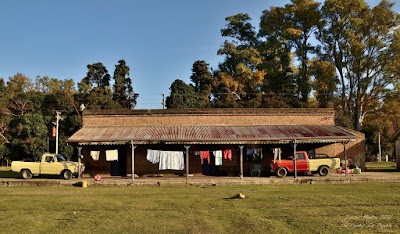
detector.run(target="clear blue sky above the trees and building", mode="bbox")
[0,0,399,109]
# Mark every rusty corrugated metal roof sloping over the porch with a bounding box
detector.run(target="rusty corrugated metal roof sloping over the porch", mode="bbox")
[68,125,356,144]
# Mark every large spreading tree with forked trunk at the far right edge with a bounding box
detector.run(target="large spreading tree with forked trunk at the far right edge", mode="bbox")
[318,0,400,131]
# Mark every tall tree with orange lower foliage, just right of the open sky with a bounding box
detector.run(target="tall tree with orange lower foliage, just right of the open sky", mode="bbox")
[217,14,266,107]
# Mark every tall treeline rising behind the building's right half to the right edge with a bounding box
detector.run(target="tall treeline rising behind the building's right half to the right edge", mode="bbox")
[166,0,400,158]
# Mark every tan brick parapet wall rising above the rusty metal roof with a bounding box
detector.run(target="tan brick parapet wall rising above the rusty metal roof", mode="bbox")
[83,109,334,127]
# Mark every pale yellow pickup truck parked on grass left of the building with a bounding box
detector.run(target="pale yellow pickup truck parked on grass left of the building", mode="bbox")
[11,153,84,180]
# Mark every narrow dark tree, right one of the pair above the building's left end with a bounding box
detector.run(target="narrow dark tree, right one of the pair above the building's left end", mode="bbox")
[113,59,138,109]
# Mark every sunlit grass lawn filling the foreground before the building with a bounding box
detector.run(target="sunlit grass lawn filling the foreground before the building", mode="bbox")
[0,183,400,233]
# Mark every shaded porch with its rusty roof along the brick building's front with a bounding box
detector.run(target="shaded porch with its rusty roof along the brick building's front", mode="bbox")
[69,125,356,181]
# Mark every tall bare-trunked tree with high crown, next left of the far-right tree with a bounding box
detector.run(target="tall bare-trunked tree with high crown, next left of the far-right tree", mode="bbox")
[260,0,321,106]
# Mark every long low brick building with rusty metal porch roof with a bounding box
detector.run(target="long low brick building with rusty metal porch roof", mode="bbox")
[68,109,365,176]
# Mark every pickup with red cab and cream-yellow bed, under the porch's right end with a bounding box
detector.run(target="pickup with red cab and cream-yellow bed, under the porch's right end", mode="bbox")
[271,151,340,178]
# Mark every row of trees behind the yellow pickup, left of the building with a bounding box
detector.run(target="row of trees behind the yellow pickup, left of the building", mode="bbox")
[0,60,138,161]
